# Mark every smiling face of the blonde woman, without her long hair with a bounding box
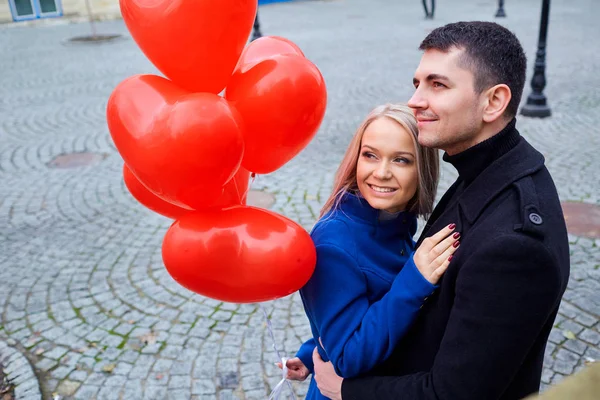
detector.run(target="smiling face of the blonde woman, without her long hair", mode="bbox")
[356,117,418,212]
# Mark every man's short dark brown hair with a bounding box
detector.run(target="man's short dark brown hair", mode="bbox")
[419,21,527,117]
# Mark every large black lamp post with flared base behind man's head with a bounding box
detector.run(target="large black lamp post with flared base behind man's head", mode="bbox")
[521,0,552,118]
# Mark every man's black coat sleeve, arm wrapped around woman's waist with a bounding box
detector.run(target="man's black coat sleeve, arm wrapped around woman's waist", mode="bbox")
[342,235,562,400]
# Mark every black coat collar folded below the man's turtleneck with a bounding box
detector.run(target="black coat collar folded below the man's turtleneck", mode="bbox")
[459,137,544,224]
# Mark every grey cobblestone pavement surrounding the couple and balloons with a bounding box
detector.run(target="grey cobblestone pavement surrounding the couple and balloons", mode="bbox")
[0,0,600,400]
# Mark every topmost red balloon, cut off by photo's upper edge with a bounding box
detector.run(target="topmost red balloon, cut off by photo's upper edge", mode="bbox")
[120,0,257,94]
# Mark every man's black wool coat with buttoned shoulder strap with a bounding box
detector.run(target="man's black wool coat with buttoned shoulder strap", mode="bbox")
[342,137,570,400]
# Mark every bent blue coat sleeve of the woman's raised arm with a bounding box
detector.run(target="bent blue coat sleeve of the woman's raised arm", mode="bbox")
[302,244,435,377]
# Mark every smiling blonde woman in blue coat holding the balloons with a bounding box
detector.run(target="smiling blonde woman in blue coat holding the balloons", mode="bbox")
[278,104,460,400]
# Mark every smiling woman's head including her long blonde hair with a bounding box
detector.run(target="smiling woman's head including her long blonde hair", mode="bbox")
[320,104,439,217]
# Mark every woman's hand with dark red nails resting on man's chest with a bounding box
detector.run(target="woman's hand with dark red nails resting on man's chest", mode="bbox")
[414,224,460,285]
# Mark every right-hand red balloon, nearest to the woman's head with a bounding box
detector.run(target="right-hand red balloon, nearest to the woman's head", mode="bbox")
[225,54,327,174]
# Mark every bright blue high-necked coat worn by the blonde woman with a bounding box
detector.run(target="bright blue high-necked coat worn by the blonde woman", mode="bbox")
[297,194,436,400]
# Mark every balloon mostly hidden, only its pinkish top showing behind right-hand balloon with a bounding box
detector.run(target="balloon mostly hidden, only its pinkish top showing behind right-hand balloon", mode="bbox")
[235,36,304,72]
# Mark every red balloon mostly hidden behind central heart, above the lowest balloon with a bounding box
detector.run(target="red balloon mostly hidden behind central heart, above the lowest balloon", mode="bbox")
[123,164,250,219]
